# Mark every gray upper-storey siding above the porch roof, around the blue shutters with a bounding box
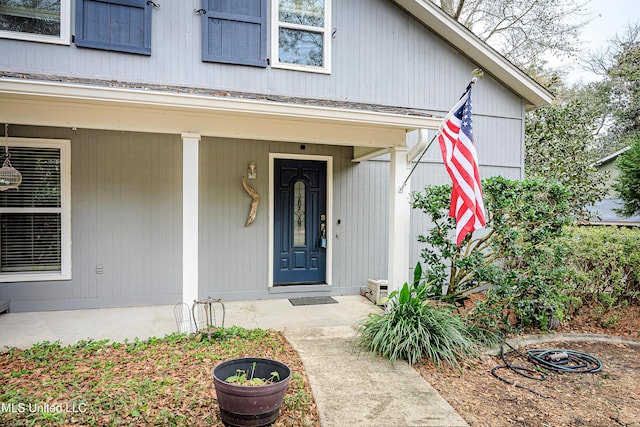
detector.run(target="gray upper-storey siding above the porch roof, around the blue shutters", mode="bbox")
[0,0,520,117]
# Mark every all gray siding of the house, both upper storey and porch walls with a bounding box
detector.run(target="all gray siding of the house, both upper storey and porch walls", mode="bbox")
[0,0,536,311]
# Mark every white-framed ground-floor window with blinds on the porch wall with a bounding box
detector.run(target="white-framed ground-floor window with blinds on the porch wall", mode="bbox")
[0,138,71,282]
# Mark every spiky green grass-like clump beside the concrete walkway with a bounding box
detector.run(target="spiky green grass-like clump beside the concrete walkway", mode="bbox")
[355,283,498,368]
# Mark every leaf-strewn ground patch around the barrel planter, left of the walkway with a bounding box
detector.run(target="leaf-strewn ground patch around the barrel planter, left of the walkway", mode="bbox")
[0,331,319,426]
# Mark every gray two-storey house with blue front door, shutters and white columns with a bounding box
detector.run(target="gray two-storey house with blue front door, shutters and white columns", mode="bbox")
[0,0,552,311]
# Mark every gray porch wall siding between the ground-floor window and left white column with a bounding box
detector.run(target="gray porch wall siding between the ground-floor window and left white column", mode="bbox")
[0,126,182,311]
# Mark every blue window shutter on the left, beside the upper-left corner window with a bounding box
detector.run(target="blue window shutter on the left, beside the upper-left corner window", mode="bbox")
[75,0,152,55]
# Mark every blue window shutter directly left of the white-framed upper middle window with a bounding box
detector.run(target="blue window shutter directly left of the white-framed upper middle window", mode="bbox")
[202,0,267,67]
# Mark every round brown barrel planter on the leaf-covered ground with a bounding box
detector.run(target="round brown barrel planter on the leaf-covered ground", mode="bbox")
[213,357,291,427]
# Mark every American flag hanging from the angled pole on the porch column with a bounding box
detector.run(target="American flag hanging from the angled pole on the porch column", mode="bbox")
[438,84,486,246]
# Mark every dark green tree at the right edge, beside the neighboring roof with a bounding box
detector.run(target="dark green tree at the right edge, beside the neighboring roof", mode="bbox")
[613,137,640,216]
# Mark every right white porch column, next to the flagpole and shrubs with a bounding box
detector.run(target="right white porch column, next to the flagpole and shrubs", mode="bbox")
[388,147,411,293]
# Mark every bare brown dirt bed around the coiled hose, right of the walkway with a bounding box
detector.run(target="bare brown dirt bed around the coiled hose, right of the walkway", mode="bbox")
[414,306,640,427]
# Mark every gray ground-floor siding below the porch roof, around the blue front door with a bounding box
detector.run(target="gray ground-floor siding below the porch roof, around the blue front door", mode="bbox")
[0,119,521,311]
